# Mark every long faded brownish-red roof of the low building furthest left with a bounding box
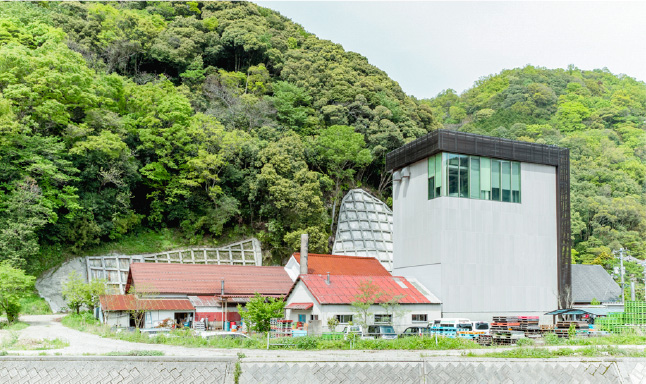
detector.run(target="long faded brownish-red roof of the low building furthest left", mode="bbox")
[126,263,293,296]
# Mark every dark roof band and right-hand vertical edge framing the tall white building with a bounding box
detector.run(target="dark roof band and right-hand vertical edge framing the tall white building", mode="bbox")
[386,129,572,308]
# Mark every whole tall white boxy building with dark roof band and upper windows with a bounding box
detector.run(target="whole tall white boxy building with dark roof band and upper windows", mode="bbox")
[386,130,571,321]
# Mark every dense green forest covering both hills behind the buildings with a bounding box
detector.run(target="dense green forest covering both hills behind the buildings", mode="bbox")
[0,2,646,284]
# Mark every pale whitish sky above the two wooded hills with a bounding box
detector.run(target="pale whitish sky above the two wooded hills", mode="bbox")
[257,1,646,98]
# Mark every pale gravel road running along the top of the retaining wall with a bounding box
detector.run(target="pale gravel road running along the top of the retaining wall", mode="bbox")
[5,314,644,361]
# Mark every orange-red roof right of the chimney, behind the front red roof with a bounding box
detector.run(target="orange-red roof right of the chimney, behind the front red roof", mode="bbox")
[292,252,390,276]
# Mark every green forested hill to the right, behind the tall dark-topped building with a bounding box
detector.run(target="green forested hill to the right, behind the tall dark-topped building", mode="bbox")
[424,66,646,277]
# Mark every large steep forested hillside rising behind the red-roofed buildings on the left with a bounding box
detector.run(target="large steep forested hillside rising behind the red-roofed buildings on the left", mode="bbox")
[0,2,440,273]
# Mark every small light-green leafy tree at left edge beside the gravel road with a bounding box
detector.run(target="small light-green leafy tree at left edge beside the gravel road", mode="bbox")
[0,260,36,323]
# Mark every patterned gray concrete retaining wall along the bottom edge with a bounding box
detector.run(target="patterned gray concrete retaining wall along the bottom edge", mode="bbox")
[0,356,646,384]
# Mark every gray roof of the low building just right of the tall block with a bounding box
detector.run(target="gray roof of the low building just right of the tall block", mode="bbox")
[572,264,621,303]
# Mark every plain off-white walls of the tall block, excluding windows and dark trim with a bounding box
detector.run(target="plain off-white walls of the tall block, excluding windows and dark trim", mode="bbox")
[393,159,558,321]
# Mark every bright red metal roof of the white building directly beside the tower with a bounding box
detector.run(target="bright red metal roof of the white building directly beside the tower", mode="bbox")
[299,275,431,304]
